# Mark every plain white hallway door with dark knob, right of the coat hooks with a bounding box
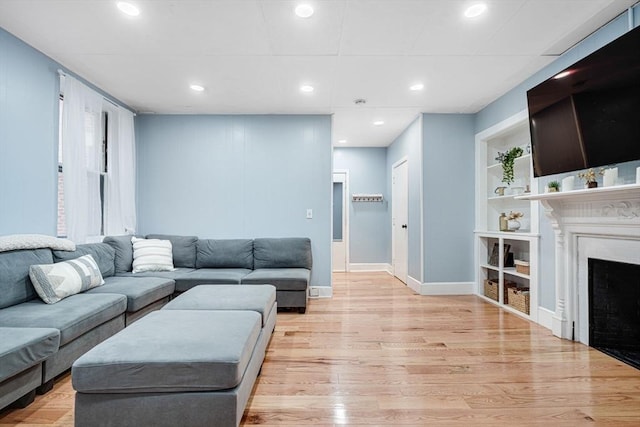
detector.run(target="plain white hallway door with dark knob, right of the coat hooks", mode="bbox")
[391,160,409,283]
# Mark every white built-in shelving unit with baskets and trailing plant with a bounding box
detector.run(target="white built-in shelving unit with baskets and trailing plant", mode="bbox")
[475,110,539,322]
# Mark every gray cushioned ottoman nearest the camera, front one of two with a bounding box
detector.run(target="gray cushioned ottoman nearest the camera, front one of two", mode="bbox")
[71,310,264,426]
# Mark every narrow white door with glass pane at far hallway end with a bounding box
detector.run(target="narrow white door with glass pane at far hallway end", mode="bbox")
[331,172,349,272]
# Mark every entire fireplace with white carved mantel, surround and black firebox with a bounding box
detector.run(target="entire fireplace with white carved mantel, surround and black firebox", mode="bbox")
[522,183,640,348]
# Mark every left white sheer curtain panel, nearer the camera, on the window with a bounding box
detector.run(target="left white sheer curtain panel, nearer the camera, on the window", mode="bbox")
[62,76,102,243]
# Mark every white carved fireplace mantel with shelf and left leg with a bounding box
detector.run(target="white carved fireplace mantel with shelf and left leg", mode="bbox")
[516,184,640,343]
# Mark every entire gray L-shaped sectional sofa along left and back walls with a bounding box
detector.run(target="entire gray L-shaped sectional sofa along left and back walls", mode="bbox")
[0,235,312,410]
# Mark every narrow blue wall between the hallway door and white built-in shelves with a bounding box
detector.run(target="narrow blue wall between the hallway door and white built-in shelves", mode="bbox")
[422,114,475,283]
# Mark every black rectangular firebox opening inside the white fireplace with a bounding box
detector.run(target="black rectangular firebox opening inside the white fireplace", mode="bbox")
[588,258,640,369]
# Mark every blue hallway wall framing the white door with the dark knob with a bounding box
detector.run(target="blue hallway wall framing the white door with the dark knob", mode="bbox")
[387,117,422,282]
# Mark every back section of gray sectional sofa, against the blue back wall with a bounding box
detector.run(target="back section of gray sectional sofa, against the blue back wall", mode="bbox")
[104,234,313,313]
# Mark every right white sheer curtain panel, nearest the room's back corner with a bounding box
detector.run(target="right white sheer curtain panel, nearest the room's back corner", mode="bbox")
[105,107,136,235]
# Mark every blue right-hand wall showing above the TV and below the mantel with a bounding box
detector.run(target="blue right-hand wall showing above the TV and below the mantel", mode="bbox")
[475,6,640,311]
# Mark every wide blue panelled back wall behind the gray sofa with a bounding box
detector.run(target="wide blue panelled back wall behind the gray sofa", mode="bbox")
[136,115,332,286]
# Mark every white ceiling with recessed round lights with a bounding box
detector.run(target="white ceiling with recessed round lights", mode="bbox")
[0,0,637,147]
